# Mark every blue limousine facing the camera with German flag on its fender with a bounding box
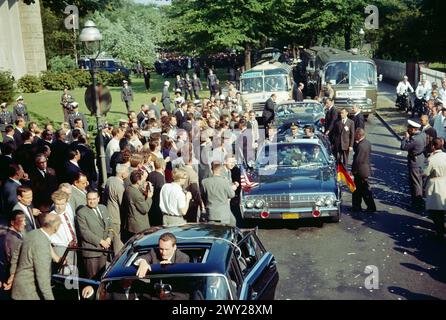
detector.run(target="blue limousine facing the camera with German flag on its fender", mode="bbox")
[240,139,341,222]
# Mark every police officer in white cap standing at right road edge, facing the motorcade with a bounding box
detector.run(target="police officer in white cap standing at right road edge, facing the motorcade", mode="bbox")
[401,120,426,209]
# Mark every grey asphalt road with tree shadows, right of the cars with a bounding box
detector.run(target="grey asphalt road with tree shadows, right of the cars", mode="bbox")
[254,112,446,300]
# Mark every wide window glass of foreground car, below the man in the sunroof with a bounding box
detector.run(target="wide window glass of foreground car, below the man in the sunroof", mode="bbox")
[101,274,231,300]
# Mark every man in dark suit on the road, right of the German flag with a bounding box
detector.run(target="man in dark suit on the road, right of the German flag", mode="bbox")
[352,128,376,213]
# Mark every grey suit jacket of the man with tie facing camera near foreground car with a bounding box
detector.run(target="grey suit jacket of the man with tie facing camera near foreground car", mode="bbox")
[75,204,113,258]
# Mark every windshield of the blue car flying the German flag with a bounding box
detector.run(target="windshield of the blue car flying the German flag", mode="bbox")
[257,143,328,169]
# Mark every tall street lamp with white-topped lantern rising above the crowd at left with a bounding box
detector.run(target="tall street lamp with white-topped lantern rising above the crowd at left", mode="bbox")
[79,20,107,190]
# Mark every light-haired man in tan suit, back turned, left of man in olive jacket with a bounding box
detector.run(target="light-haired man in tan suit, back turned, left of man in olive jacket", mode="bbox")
[104,163,129,254]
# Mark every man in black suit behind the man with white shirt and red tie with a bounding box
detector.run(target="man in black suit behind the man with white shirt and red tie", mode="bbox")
[29,154,59,212]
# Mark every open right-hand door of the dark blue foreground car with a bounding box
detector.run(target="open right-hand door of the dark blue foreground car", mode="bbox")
[238,232,279,300]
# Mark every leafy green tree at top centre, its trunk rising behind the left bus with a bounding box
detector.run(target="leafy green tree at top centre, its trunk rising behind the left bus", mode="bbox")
[169,0,273,69]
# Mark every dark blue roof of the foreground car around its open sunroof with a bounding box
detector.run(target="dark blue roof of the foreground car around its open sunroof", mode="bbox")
[103,224,240,280]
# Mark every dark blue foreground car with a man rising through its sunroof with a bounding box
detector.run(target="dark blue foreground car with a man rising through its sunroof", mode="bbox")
[49,224,279,300]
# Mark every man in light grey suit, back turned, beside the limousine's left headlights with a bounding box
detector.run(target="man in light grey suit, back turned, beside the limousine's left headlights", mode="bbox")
[202,161,237,226]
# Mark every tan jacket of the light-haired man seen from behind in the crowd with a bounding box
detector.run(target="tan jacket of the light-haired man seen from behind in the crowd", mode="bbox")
[104,176,125,226]
